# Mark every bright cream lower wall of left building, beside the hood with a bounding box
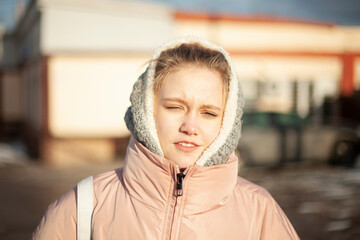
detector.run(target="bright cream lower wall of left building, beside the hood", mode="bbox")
[49,56,150,137]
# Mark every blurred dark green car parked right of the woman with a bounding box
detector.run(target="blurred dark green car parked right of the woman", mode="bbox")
[237,112,360,166]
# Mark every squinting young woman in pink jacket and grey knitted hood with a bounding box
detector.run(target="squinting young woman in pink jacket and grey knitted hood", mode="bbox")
[33,38,299,240]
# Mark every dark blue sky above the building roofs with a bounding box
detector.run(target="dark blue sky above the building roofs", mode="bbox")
[0,0,360,32]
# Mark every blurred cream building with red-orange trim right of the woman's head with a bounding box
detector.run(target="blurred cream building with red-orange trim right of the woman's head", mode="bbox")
[175,13,360,114]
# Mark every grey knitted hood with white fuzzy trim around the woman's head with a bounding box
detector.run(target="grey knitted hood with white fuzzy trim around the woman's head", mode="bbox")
[125,37,244,166]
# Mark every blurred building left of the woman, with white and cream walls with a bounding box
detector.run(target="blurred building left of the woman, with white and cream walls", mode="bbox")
[1,0,173,163]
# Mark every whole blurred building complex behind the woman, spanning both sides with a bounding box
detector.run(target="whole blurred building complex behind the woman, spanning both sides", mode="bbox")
[0,0,360,164]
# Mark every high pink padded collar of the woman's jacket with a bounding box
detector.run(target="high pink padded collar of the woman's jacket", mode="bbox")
[123,137,238,215]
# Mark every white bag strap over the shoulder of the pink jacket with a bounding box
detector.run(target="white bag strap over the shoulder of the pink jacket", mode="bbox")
[77,176,94,240]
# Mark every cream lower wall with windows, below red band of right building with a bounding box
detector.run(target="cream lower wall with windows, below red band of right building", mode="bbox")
[232,55,342,112]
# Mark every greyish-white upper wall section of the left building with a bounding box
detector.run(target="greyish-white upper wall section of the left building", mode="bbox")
[40,0,173,55]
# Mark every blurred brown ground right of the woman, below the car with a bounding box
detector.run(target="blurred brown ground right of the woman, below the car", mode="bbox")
[240,163,360,240]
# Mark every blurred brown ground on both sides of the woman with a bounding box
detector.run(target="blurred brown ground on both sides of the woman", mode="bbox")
[0,142,360,240]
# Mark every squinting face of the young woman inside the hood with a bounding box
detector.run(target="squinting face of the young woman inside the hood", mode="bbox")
[154,66,225,168]
